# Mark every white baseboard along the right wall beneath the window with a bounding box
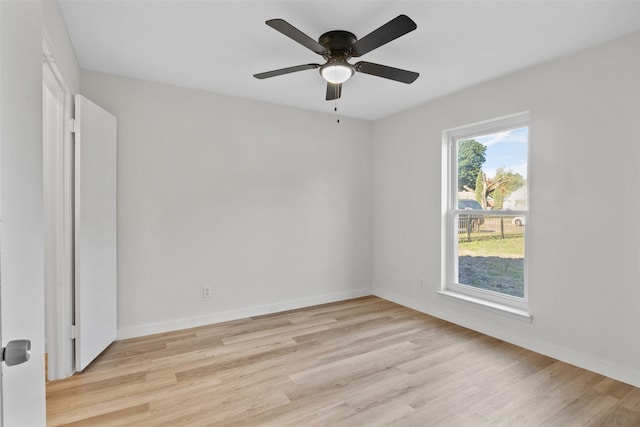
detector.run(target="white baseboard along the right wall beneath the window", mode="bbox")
[373,289,640,387]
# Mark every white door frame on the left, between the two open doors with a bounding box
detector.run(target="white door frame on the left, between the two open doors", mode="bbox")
[42,34,75,380]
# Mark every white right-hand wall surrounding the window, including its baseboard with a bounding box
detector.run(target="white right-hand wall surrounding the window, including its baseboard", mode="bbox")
[372,33,640,386]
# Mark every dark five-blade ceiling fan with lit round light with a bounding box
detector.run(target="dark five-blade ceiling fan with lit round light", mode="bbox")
[253,15,420,101]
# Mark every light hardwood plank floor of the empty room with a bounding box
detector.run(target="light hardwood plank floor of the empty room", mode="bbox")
[47,297,640,427]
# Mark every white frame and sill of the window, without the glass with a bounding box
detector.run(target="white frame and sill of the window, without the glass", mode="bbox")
[438,112,532,321]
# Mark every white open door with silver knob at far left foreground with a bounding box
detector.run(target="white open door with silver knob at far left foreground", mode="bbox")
[0,1,46,427]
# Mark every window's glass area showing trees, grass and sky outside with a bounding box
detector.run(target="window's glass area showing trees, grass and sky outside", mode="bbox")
[454,127,528,298]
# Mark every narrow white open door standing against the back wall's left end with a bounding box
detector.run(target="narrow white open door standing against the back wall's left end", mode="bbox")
[74,95,117,371]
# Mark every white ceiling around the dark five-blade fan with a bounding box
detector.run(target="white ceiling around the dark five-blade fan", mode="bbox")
[60,0,640,120]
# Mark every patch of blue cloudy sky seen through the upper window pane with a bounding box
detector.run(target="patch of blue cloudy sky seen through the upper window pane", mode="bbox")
[473,127,529,179]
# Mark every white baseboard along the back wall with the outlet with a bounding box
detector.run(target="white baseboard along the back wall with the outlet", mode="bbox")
[117,288,371,340]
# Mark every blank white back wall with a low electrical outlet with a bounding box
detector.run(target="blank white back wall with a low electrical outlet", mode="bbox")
[81,70,371,338]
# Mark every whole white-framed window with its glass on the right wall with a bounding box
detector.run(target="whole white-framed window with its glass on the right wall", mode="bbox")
[441,113,530,319]
